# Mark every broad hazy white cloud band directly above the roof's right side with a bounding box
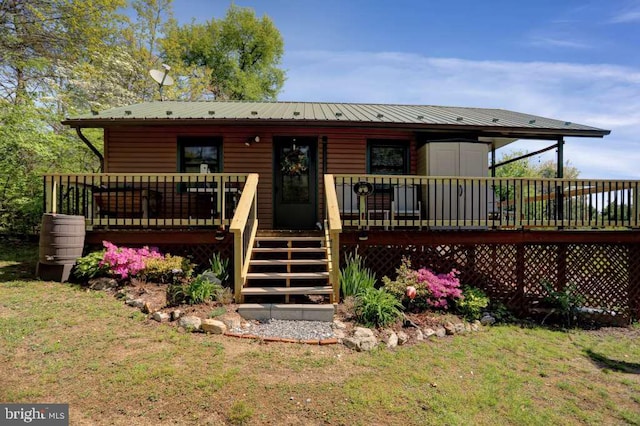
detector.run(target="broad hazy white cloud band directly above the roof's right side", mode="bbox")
[280,51,640,179]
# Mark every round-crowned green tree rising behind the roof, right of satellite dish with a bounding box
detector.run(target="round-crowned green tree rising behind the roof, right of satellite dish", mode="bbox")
[161,5,285,100]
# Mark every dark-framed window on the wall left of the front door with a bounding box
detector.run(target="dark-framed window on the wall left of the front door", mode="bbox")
[178,137,222,173]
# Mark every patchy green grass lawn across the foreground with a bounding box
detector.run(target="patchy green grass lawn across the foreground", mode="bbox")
[0,241,640,425]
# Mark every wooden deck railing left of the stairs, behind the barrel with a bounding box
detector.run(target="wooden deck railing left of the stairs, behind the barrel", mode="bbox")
[44,173,247,228]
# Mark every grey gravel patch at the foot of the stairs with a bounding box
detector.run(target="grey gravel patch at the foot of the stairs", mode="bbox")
[234,319,333,340]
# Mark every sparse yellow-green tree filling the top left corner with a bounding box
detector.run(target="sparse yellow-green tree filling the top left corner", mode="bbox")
[0,0,126,108]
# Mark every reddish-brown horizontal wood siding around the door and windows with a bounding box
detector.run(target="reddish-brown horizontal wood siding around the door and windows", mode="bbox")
[105,125,417,229]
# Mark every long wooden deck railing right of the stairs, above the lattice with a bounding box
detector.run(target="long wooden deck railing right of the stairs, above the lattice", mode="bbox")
[334,175,640,229]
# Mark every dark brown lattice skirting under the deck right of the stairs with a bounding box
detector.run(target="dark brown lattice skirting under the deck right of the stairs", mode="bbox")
[341,241,640,324]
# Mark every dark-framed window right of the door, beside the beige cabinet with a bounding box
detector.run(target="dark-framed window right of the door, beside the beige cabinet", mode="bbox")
[367,141,409,175]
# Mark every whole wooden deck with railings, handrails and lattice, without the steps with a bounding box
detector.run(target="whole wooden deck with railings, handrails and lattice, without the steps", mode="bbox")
[45,174,640,322]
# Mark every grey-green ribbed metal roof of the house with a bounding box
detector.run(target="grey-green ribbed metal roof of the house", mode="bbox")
[63,101,610,137]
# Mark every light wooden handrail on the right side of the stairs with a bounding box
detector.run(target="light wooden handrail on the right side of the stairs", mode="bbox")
[324,174,342,303]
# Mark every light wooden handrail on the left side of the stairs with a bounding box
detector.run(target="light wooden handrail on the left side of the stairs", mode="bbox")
[229,173,258,303]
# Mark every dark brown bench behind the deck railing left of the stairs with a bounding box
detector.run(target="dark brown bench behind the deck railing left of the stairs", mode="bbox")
[93,188,162,219]
